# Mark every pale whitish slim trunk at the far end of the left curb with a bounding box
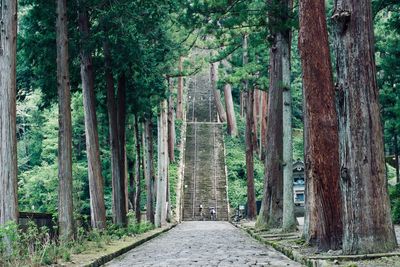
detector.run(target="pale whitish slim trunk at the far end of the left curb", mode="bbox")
[155,100,168,227]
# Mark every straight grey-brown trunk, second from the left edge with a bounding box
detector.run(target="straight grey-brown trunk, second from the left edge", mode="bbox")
[56,0,74,240]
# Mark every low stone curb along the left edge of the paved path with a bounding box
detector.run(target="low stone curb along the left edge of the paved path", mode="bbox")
[82,224,178,267]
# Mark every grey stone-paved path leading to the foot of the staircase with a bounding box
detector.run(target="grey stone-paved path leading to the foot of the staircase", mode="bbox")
[106,221,301,267]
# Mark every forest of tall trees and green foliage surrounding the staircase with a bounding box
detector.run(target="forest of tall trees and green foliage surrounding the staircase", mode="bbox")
[0,0,400,266]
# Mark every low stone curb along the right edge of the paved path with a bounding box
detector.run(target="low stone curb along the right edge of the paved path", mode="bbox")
[232,223,332,267]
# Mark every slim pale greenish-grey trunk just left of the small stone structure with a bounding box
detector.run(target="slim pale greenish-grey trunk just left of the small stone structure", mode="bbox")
[282,23,297,234]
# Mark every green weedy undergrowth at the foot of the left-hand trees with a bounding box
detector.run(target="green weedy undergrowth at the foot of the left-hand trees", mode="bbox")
[0,213,154,267]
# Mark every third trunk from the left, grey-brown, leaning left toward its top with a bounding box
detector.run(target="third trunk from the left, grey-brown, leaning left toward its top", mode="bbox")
[79,7,106,229]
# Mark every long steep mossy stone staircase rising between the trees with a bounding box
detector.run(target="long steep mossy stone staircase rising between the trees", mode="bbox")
[182,73,228,221]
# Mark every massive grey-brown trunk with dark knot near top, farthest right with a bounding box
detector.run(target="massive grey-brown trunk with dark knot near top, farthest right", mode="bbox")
[332,0,397,254]
